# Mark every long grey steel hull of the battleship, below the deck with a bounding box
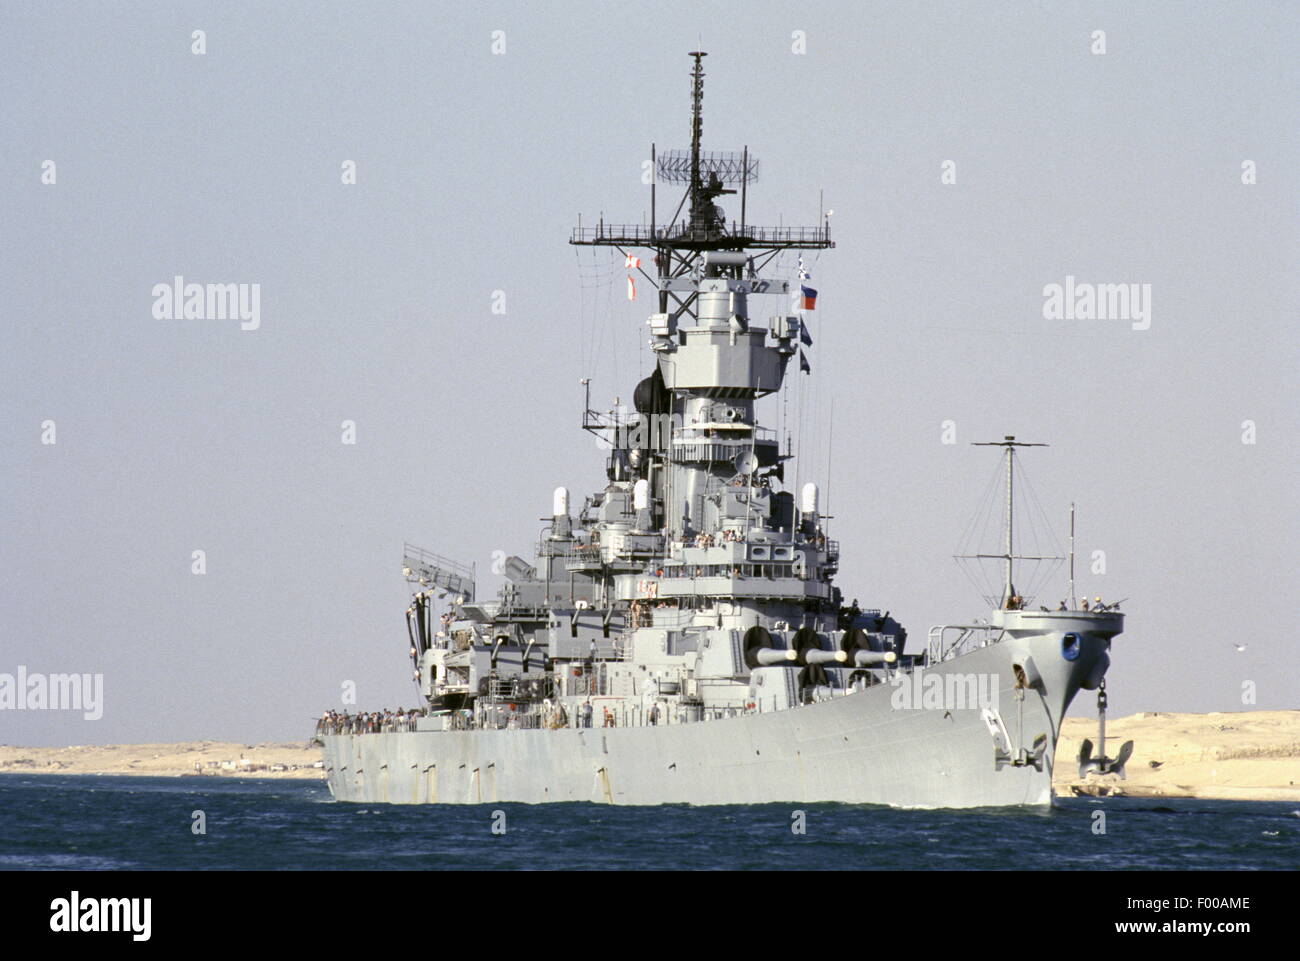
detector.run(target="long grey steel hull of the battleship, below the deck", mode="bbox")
[320,637,1105,808]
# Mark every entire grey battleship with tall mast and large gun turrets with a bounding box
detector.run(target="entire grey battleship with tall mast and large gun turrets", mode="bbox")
[316,52,1127,808]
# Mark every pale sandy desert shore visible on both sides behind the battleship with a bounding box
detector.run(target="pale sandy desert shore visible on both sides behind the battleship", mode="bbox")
[0,711,1300,802]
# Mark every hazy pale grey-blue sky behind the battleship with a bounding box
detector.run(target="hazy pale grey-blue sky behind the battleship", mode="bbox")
[0,3,1300,745]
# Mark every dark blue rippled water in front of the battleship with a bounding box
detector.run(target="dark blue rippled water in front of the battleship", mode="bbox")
[0,774,1300,870]
